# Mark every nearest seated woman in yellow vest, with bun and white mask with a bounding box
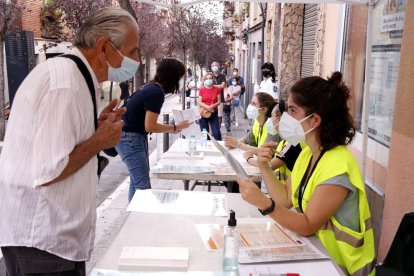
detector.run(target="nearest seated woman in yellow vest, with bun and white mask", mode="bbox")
[237,72,375,275]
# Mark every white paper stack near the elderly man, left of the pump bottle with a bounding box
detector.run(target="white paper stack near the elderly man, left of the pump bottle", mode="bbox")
[119,246,189,271]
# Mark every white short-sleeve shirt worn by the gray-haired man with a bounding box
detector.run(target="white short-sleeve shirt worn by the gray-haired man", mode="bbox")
[0,49,100,261]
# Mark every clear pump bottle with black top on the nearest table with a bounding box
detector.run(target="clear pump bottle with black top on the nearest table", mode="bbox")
[223,210,240,271]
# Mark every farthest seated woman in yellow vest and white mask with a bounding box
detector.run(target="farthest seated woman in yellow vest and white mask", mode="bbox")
[224,92,278,155]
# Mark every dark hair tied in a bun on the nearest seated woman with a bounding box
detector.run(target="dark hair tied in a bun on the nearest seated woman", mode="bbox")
[290,72,355,150]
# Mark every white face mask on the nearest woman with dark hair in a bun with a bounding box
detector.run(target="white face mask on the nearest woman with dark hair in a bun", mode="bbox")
[279,112,314,146]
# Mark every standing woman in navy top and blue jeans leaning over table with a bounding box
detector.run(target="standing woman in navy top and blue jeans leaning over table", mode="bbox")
[116,58,190,201]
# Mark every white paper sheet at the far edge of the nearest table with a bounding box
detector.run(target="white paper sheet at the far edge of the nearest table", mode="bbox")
[127,189,227,217]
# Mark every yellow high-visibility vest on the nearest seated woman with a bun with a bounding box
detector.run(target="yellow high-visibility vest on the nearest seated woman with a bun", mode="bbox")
[291,146,375,276]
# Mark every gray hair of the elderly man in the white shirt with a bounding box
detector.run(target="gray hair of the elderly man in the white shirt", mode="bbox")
[73,8,139,48]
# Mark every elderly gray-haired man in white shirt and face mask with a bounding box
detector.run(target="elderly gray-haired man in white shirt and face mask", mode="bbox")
[0,8,139,275]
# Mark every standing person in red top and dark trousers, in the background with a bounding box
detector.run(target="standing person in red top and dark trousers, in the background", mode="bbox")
[198,73,221,141]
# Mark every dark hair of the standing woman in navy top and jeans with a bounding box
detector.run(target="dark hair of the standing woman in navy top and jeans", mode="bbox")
[152,58,185,94]
